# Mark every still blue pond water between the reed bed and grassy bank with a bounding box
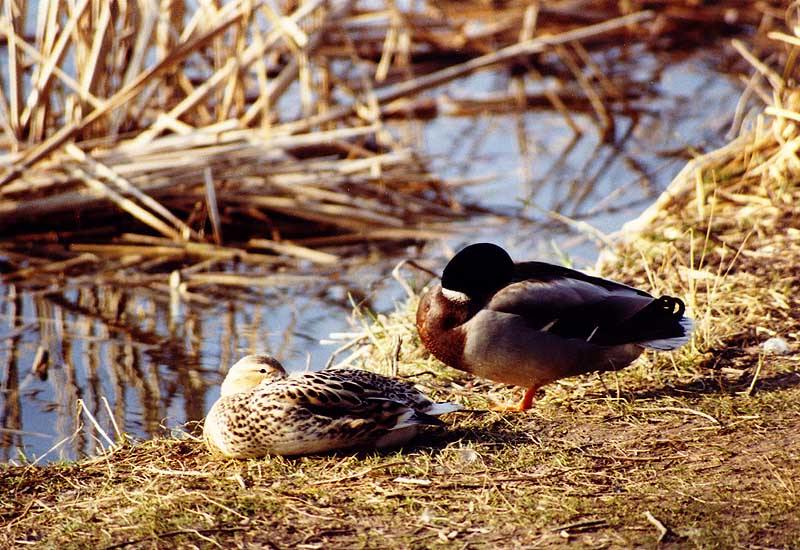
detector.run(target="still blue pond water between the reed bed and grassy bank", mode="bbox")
[0,45,741,462]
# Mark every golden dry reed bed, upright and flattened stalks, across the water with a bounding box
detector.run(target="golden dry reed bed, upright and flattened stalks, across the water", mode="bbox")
[0,0,779,286]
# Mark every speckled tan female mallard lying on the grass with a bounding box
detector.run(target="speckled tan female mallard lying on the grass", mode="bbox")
[203,355,461,458]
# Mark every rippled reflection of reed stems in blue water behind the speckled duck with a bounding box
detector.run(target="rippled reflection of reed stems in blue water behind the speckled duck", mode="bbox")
[0,274,362,461]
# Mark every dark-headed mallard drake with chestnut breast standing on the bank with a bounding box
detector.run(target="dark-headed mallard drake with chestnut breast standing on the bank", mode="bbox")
[417,243,692,410]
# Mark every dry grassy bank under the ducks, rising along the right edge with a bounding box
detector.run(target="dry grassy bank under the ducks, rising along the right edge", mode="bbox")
[0,2,800,548]
